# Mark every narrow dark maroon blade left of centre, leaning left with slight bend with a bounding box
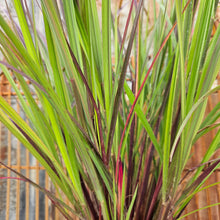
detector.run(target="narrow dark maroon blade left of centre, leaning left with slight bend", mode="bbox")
[66,40,107,165]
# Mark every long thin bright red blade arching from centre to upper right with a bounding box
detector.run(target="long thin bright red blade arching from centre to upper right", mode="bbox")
[116,0,191,184]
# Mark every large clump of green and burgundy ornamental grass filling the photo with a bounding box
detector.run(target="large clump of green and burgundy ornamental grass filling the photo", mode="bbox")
[0,0,220,220]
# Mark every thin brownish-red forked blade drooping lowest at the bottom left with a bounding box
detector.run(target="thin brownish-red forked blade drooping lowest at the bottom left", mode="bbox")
[0,161,80,220]
